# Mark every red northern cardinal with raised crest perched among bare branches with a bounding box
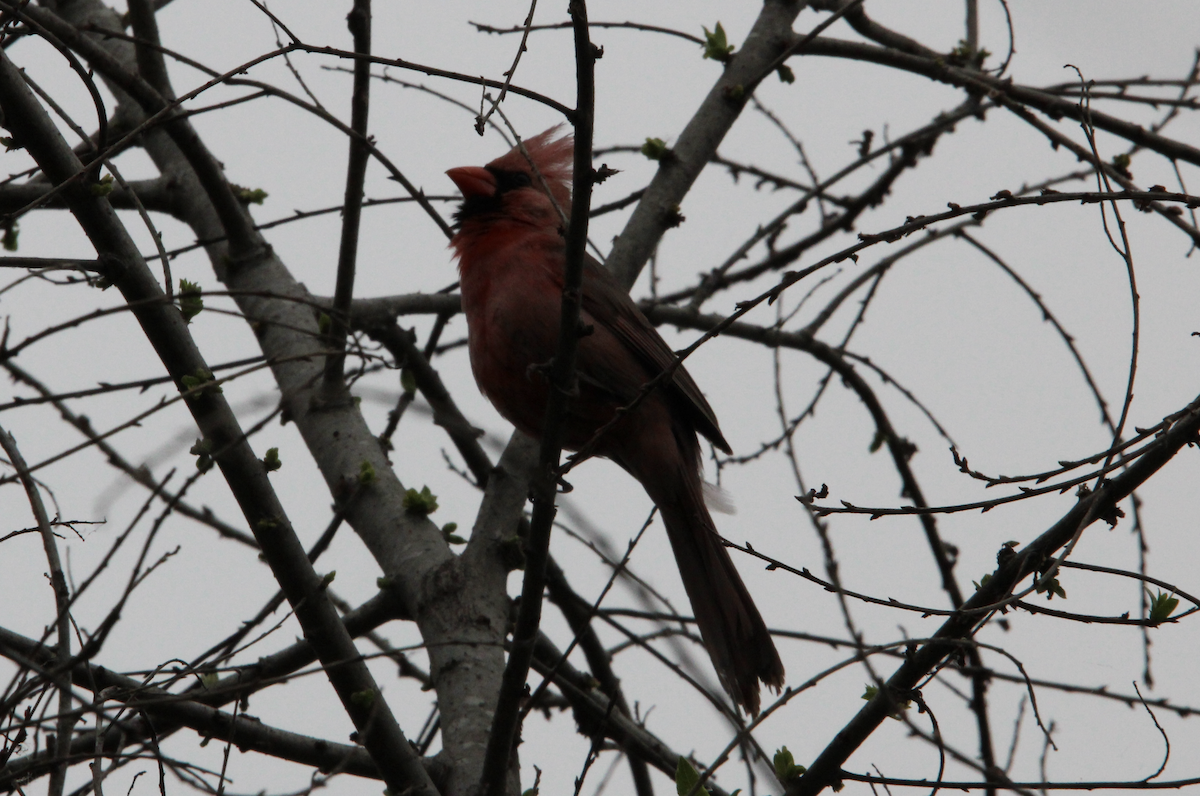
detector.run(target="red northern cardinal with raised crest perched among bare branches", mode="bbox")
[446,127,784,714]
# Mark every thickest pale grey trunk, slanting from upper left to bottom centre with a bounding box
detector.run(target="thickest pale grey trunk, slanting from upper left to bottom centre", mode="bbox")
[32,0,508,792]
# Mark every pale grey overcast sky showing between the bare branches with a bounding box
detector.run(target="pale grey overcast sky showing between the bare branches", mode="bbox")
[0,0,1200,794]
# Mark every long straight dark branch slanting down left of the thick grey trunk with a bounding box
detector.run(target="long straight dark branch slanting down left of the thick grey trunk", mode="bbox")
[0,42,436,795]
